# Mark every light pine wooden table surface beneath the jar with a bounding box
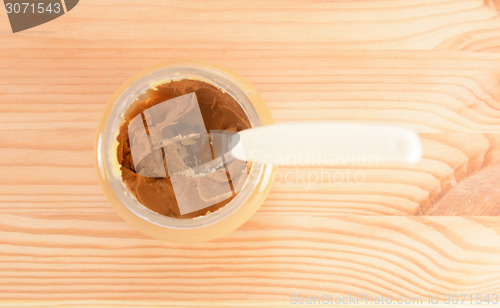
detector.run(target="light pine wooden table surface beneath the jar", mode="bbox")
[0,0,500,307]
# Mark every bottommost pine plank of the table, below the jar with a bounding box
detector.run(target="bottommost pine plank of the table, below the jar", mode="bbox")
[0,212,500,301]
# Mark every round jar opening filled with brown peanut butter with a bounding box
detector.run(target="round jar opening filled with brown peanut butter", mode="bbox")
[117,79,251,218]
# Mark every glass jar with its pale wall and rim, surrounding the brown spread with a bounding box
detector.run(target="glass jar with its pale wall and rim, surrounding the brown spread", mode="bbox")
[95,62,274,242]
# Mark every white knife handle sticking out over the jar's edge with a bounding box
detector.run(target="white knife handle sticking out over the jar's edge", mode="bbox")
[231,122,422,166]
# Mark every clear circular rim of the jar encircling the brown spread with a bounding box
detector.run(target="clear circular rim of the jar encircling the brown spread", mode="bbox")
[97,63,272,229]
